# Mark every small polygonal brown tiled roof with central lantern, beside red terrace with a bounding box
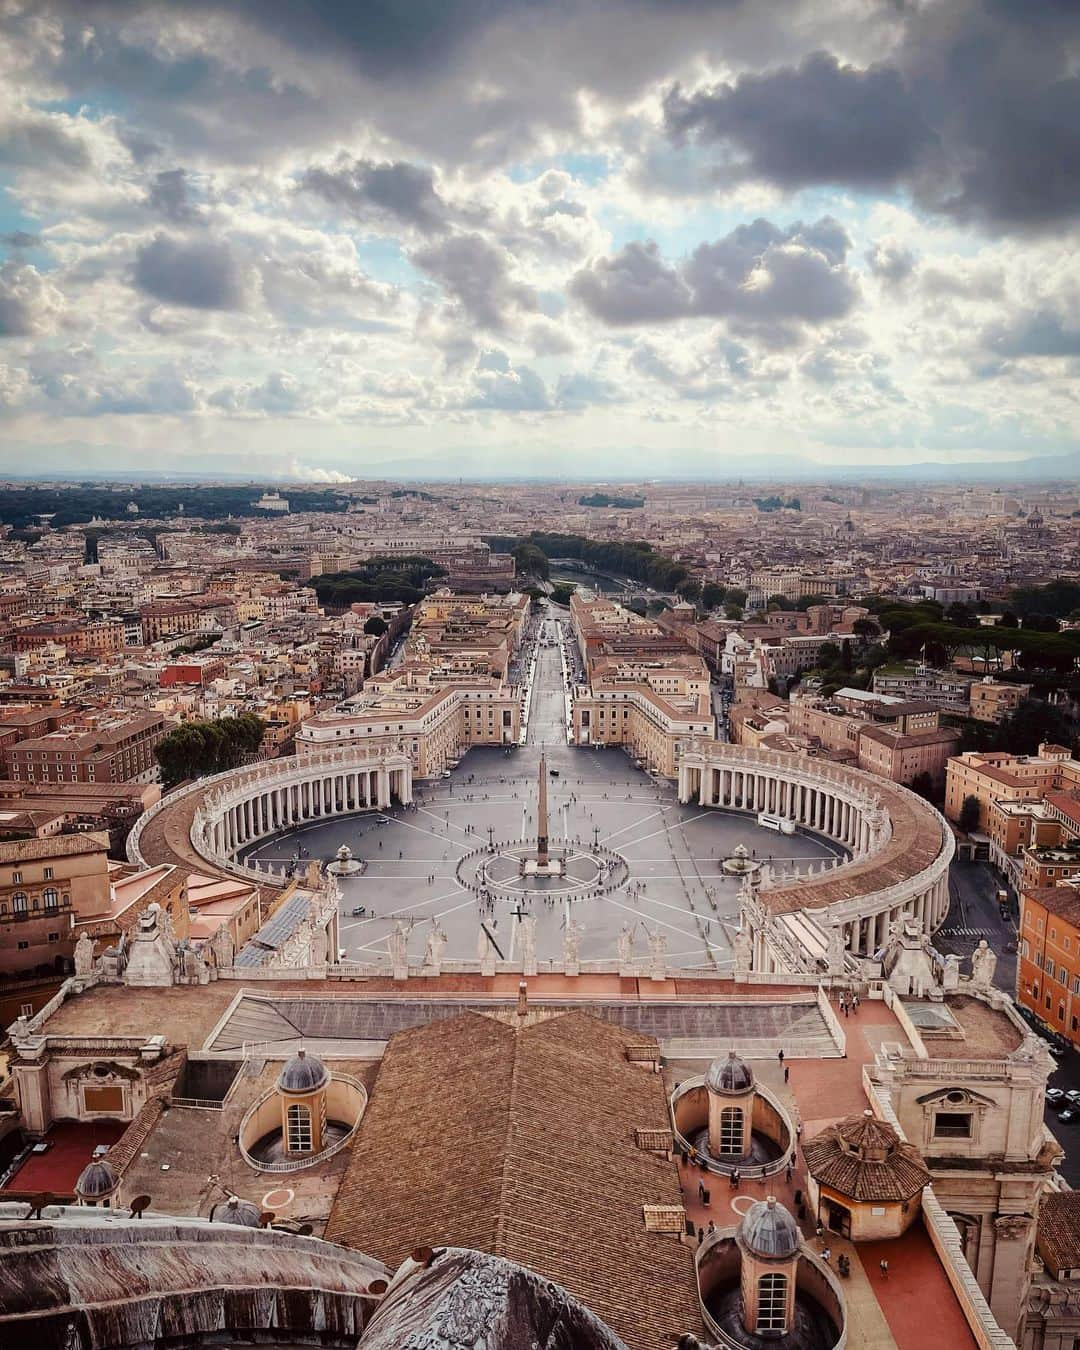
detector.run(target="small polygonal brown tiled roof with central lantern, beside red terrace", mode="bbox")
[802,1112,930,1202]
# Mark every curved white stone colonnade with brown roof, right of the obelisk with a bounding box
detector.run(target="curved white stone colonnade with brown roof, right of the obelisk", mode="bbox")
[679,740,956,973]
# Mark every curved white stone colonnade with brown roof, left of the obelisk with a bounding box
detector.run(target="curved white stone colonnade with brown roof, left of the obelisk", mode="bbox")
[127,749,413,886]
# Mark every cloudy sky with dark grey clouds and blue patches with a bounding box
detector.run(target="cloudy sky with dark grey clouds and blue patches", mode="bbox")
[0,0,1080,479]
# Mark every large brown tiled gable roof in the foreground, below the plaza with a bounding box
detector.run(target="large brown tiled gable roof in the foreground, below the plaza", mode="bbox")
[327,1013,701,1350]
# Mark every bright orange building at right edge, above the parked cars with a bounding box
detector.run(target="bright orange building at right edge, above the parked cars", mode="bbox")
[1017,883,1080,1045]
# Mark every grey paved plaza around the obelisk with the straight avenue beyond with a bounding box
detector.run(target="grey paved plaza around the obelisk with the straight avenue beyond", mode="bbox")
[244,621,844,972]
